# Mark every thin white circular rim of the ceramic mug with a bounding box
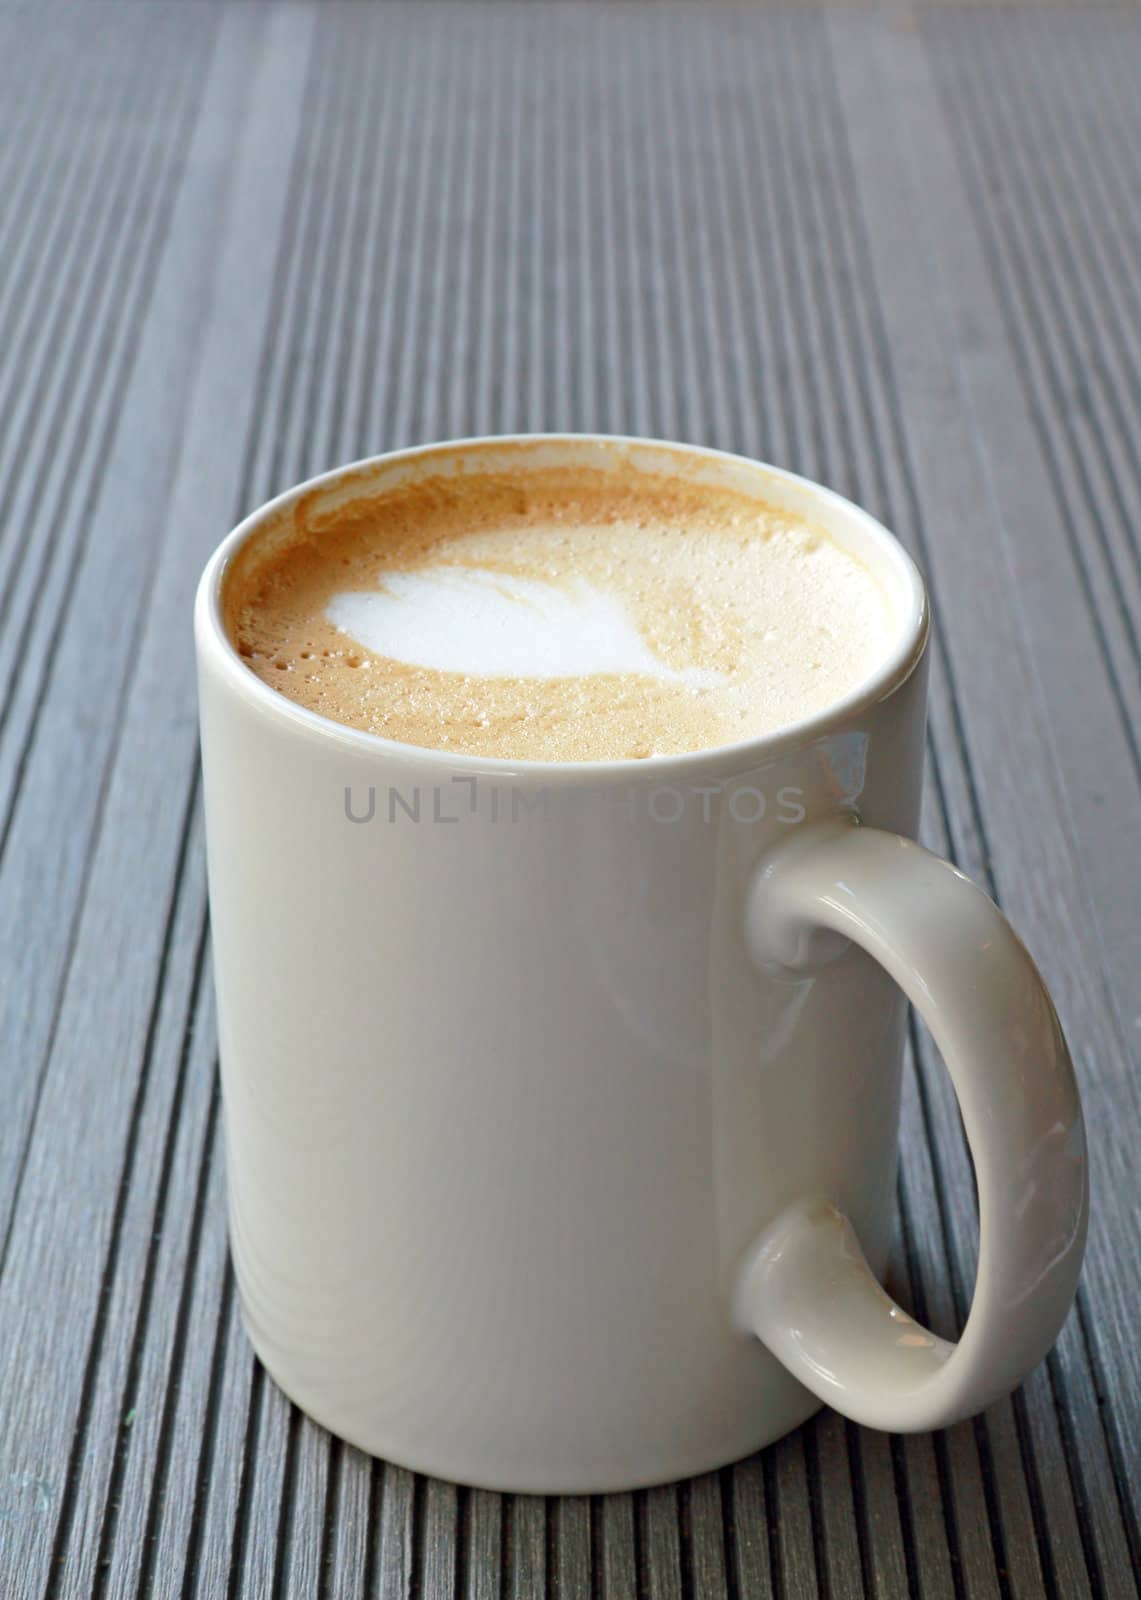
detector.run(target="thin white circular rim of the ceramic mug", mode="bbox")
[194,432,931,784]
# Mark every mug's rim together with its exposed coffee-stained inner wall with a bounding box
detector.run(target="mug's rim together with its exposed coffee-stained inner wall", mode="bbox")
[197,434,928,776]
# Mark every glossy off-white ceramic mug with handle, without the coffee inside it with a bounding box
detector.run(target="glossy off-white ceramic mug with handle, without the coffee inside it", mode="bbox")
[195,437,1087,1491]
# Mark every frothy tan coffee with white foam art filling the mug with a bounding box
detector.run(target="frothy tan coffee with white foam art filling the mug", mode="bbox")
[224,467,899,762]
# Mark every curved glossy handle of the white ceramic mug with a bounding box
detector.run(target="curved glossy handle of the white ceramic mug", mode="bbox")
[735,819,1088,1432]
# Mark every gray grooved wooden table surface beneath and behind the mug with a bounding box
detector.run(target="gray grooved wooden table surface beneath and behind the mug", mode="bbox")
[0,0,1141,1600]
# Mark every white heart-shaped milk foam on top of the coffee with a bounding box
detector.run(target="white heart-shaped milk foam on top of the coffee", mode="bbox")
[326,566,723,688]
